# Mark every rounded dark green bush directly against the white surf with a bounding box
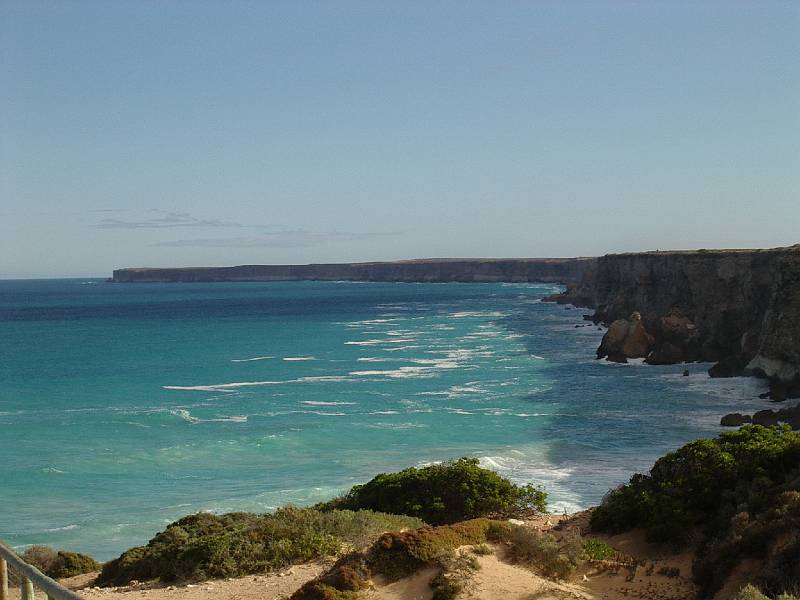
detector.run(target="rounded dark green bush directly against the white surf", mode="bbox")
[316,457,546,525]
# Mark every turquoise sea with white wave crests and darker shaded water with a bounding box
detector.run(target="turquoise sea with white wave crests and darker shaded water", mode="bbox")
[0,280,763,559]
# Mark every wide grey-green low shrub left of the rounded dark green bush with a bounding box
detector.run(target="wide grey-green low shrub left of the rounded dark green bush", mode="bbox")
[98,507,422,586]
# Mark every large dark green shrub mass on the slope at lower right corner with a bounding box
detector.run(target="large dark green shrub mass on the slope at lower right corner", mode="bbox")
[592,425,800,595]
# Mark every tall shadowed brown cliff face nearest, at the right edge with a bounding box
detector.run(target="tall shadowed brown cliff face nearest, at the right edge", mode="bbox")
[559,245,800,397]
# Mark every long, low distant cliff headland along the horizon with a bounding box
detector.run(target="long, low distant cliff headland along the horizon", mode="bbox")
[111,258,594,284]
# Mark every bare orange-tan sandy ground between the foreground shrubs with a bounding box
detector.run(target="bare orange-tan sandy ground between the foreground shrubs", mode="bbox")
[11,513,712,600]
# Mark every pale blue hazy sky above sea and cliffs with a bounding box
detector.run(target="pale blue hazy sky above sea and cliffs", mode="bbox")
[0,0,800,278]
